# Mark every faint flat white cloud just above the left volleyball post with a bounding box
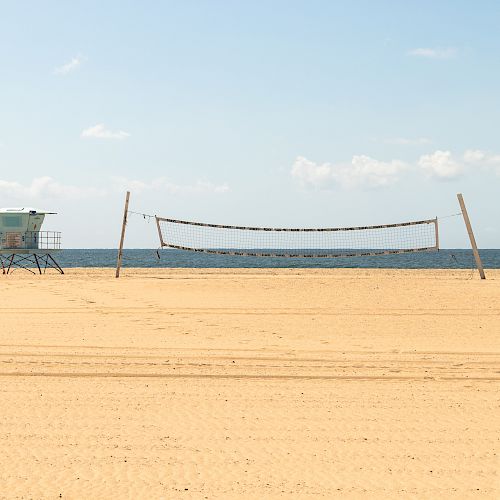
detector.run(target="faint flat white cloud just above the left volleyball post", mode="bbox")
[112,177,229,194]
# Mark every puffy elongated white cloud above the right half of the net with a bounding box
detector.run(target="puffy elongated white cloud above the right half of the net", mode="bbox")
[290,155,407,189]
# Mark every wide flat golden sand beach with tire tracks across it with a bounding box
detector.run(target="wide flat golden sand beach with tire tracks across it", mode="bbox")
[0,269,500,499]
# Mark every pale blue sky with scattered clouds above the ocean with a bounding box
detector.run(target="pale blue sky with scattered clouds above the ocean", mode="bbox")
[0,0,500,248]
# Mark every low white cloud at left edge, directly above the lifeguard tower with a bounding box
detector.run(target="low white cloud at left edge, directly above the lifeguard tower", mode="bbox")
[0,177,106,202]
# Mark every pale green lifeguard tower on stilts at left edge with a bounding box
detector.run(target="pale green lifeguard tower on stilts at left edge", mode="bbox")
[0,208,64,274]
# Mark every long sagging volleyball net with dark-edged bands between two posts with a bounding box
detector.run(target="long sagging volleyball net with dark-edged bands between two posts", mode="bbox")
[156,217,438,258]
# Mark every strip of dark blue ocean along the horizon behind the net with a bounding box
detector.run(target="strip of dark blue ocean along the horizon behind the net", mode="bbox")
[54,249,500,269]
